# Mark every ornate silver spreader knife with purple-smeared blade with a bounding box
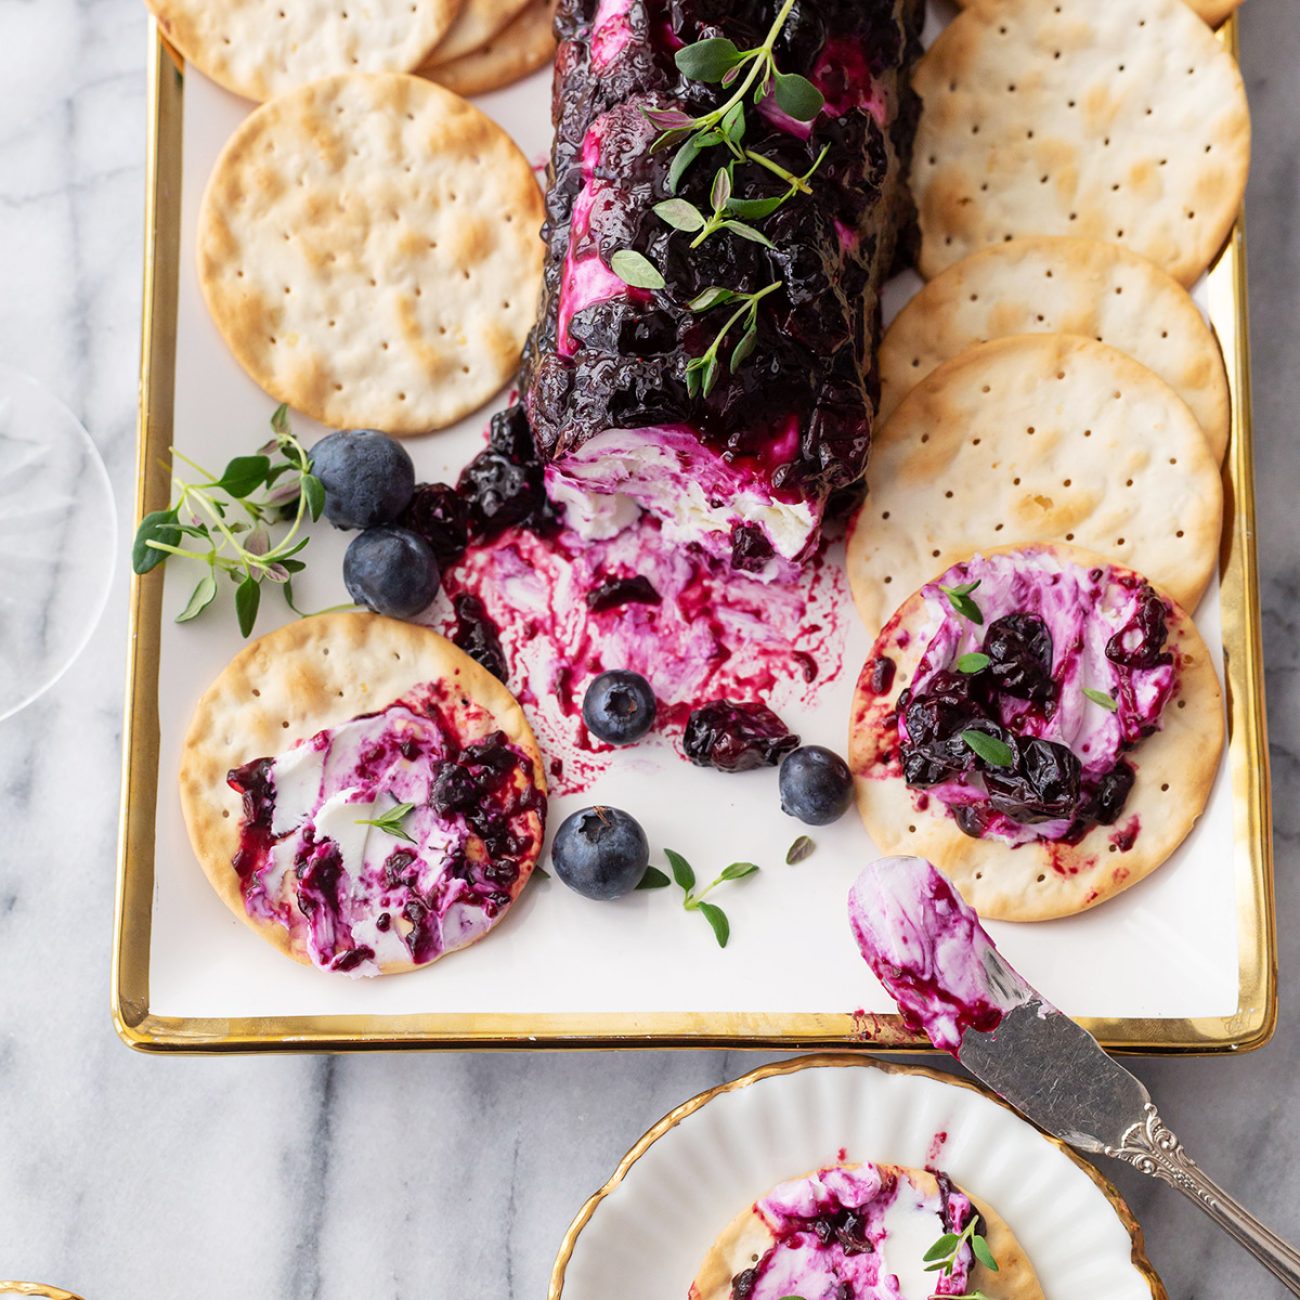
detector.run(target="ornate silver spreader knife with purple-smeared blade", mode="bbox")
[849,858,1300,1295]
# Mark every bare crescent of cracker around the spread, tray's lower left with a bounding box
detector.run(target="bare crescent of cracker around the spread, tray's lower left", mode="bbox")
[179,612,546,975]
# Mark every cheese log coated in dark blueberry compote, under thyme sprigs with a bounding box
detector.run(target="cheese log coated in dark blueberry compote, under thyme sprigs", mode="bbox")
[521,0,924,572]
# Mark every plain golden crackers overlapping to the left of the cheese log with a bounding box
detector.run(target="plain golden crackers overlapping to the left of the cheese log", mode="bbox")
[150,0,554,436]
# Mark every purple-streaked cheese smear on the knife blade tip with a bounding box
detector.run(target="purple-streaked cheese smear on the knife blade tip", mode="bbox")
[849,858,1034,1056]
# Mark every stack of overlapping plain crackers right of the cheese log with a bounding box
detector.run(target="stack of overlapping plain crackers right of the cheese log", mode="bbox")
[849,0,1251,634]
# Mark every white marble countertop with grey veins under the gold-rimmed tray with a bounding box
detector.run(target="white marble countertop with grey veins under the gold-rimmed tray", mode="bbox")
[0,0,1300,1300]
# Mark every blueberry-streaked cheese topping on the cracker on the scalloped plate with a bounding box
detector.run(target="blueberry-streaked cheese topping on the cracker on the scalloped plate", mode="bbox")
[729,1165,975,1300]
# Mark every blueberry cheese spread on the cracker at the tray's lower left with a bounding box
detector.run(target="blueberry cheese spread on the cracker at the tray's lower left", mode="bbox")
[229,685,546,975]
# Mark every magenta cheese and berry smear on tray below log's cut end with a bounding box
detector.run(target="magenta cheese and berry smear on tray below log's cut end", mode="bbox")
[423,407,848,793]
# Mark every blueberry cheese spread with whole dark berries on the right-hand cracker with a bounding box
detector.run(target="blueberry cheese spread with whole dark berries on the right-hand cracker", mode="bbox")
[883,547,1175,842]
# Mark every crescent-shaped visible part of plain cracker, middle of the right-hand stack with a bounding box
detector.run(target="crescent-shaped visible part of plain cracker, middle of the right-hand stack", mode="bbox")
[878,237,1231,460]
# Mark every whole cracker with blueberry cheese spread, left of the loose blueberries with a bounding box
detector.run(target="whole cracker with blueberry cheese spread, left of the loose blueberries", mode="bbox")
[181,614,546,975]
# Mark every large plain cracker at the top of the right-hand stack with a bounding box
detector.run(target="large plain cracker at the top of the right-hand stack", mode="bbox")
[913,0,1251,285]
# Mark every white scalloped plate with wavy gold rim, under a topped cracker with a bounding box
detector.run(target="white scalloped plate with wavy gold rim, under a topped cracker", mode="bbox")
[549,1056,1167,1300]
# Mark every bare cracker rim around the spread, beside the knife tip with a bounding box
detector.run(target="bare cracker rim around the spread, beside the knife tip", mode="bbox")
[849,546,1223,920]
